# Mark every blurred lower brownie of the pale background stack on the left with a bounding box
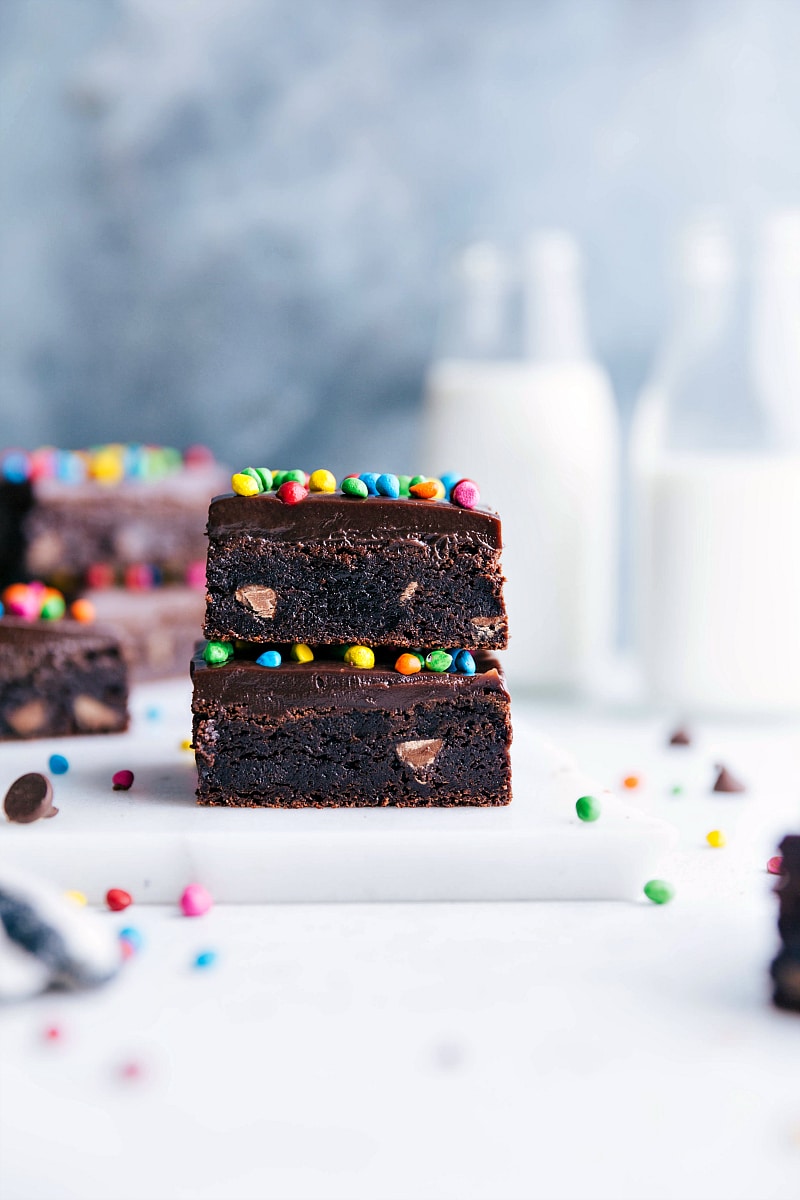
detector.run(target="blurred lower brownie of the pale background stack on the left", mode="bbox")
[84,587,205,682]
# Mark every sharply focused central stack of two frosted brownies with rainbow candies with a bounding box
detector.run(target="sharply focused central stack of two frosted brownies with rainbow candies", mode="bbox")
[192,468,511,808]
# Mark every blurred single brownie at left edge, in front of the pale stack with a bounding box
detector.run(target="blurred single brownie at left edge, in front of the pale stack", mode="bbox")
[0,617,128,740]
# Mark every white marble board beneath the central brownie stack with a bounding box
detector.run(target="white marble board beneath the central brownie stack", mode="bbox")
[0,682,676,904]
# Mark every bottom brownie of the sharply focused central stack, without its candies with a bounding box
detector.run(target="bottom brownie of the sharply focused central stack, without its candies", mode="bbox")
[192,650,511,808]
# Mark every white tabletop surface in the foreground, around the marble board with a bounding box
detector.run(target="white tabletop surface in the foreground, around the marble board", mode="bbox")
[0,707,800,1200]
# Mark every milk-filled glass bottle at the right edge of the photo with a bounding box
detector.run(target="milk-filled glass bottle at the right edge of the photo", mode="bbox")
[631,222,800,713]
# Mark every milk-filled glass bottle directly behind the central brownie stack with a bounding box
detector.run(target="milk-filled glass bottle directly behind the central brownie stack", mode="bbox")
[421,230,619,690]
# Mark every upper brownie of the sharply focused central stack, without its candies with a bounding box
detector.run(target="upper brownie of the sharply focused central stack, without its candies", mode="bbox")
[205,493,507,649]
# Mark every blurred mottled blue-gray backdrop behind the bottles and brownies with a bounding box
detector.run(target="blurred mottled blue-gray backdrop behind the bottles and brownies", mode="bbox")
[0,0,800,470]
